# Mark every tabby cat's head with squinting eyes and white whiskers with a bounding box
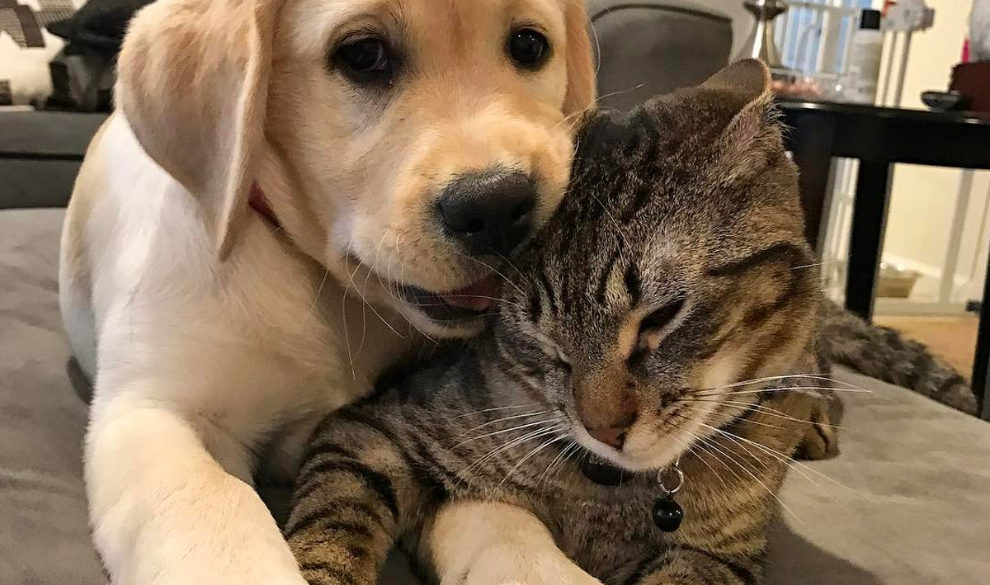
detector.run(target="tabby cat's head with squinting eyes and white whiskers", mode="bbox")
[496,61,821,470]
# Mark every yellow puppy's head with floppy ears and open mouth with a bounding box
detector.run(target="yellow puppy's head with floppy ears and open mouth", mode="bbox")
[117,0,594,335]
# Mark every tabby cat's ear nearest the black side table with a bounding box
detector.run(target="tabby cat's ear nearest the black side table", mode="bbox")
[704,59,783,183]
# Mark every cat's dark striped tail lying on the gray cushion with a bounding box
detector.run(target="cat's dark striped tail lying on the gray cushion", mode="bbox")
[821,301,977,415]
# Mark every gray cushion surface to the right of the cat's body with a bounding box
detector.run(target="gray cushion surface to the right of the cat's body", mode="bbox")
[769,371,990,585]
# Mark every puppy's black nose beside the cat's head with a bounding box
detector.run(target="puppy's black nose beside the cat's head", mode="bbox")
[437,171,536,256]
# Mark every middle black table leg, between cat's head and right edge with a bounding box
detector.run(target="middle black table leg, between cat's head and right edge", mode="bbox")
[846,161,890,321]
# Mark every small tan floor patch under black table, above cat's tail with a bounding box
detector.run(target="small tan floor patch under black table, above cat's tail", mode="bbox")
[874,315,979,378]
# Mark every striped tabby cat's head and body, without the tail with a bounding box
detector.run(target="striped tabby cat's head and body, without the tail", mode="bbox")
[285,61,835,585]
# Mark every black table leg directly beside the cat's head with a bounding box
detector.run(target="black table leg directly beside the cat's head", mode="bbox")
[788,115,835,254]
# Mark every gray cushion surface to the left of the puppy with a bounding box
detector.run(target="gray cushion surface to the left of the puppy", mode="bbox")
[0,210,105,585]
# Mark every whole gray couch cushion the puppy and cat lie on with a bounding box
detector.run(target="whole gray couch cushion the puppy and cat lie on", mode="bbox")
[0,210,990,585]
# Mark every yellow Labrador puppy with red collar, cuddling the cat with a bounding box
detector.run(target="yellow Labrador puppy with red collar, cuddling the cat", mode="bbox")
[60,0,594,585]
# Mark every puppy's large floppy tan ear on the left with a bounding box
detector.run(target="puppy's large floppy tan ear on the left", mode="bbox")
[115,0,282,258]
